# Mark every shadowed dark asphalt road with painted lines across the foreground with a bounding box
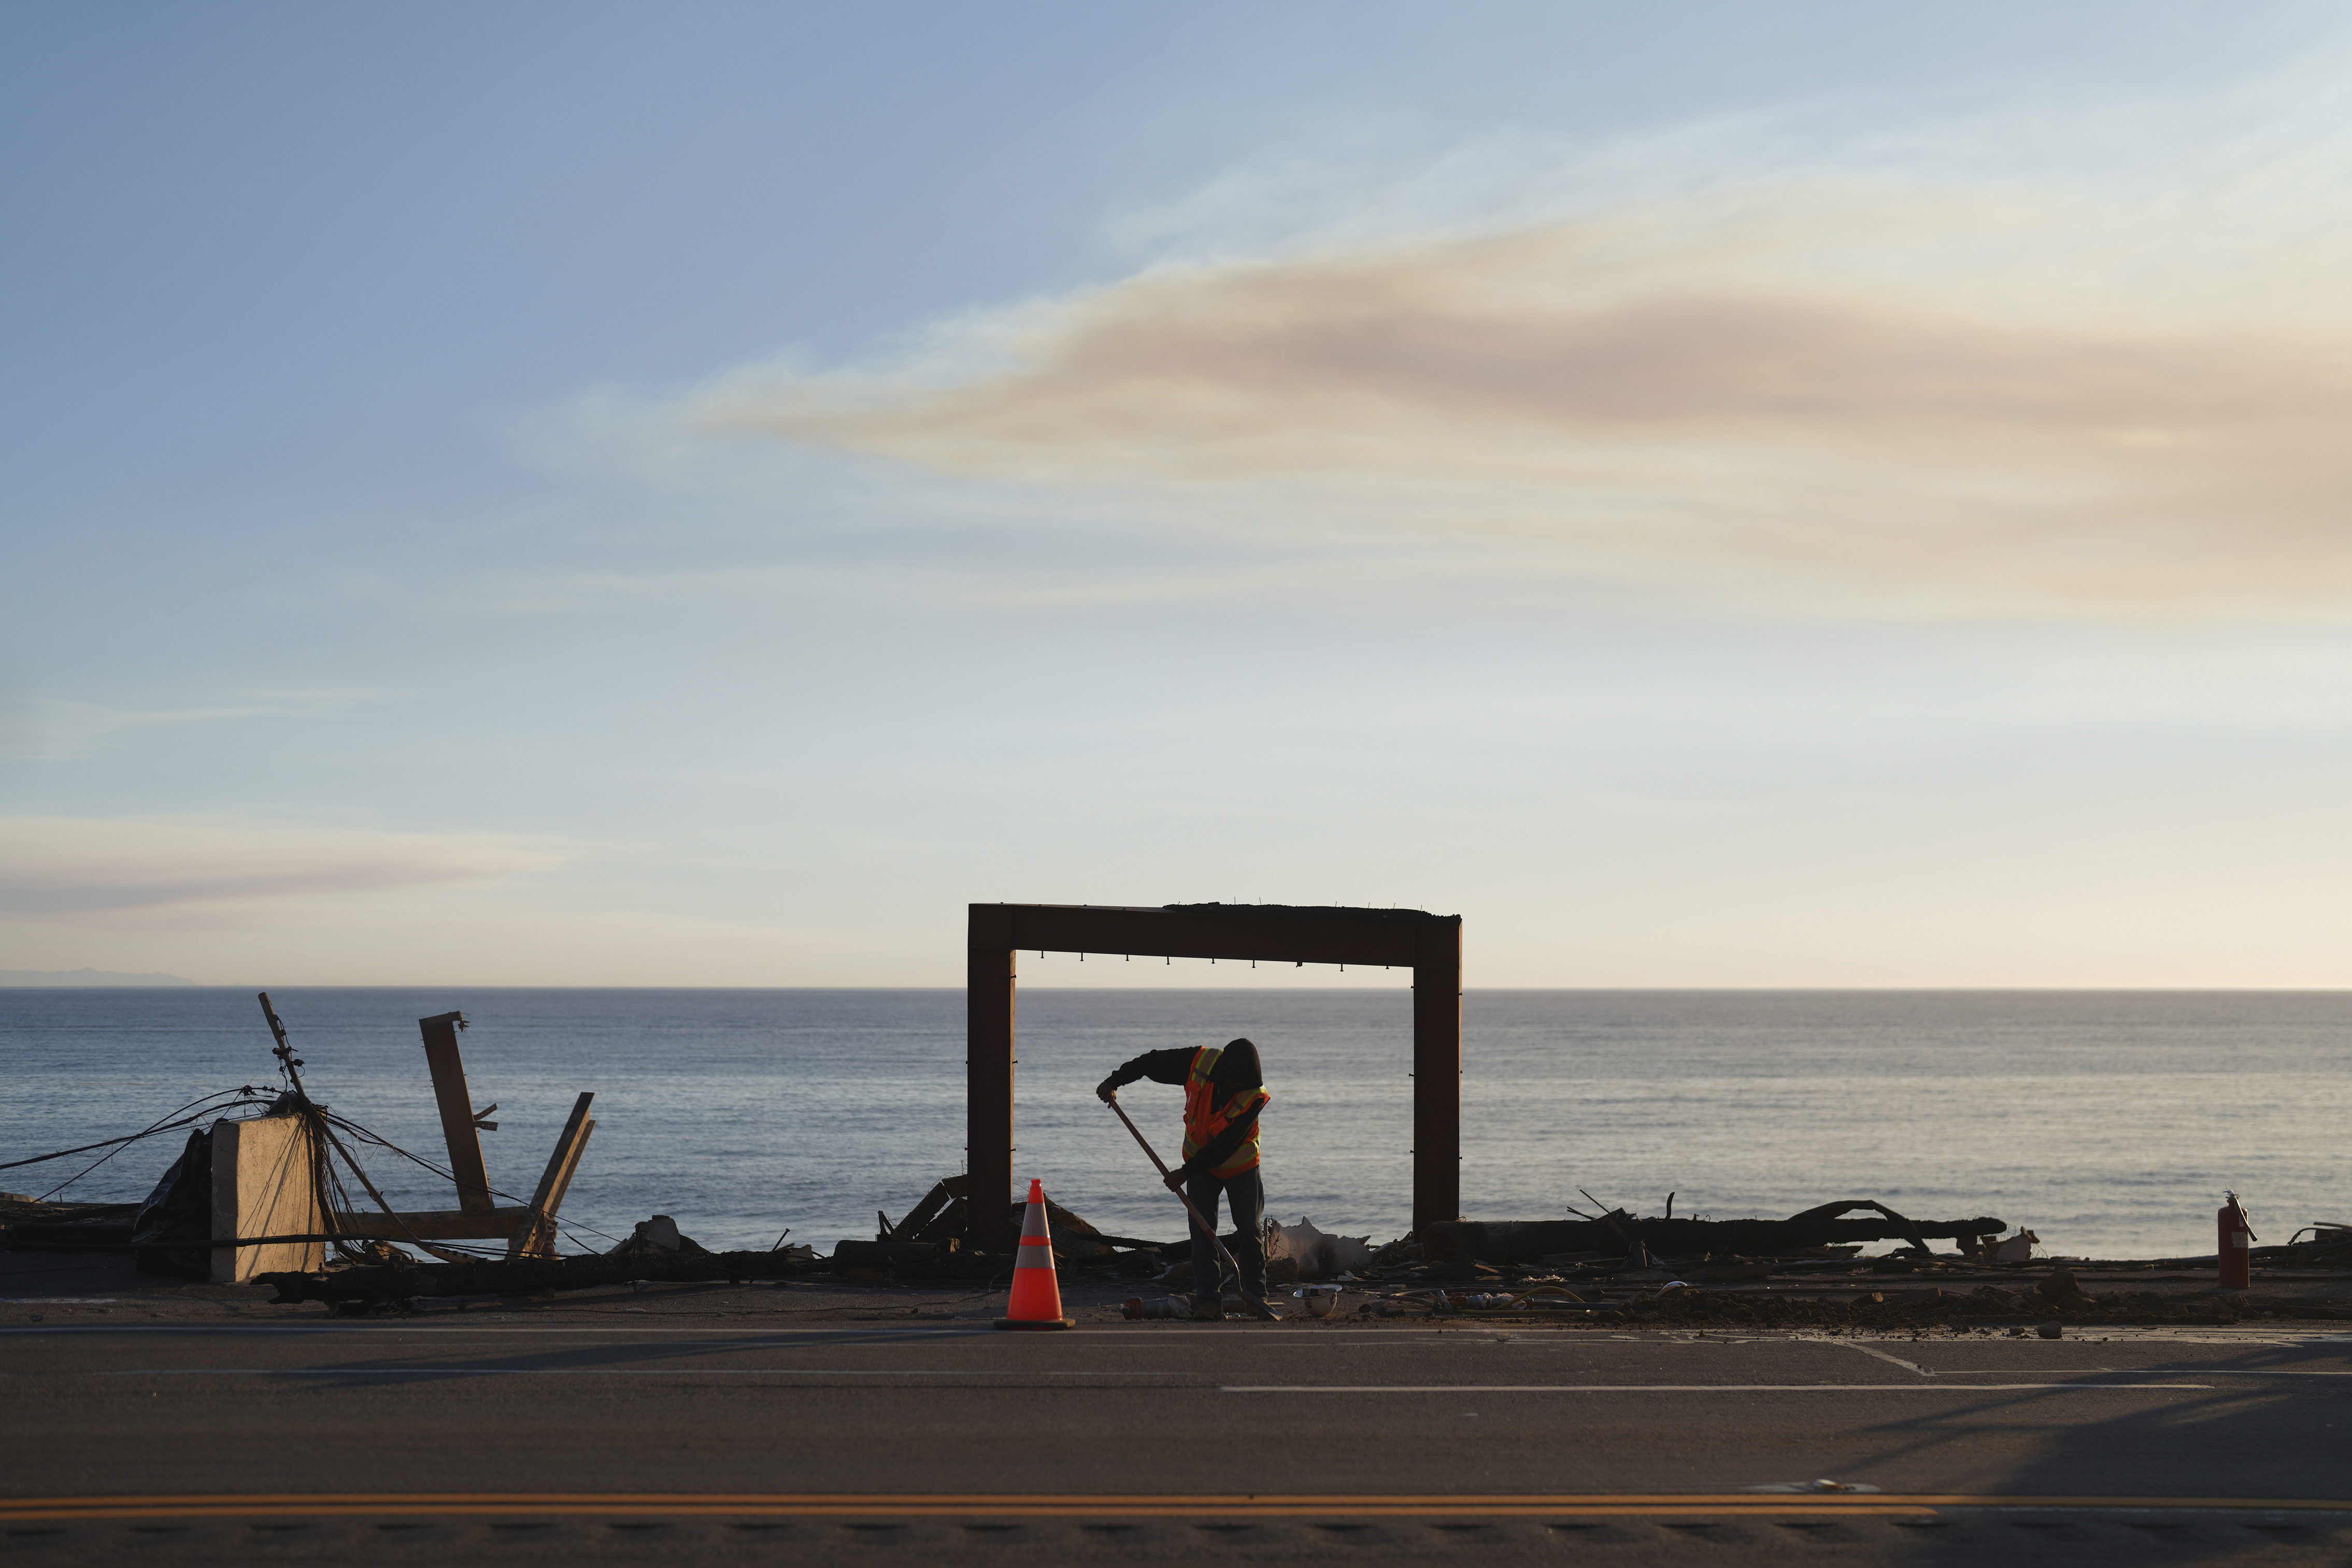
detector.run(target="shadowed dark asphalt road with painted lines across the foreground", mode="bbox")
[0,1312,2352,1563]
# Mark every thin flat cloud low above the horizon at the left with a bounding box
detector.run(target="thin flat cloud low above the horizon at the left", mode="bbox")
[0,816,560,917]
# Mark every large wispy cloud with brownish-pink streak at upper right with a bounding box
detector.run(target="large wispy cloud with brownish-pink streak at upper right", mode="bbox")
[687,50,2352,614]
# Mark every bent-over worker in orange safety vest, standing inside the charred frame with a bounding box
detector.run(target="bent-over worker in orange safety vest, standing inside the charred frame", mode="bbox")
[1094,1039,1265,1323]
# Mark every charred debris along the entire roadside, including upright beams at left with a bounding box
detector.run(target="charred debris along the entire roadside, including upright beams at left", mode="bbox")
[0,994,2352,1335]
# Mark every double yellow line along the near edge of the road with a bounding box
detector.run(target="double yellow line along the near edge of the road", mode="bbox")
[0,1493,2352,1523]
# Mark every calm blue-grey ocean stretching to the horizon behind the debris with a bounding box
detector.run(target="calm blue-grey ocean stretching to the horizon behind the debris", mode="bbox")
[0,987,2352,1258]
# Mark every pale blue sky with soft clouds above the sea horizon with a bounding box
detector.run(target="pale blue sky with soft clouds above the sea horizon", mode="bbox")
[0,0,2352,987]
